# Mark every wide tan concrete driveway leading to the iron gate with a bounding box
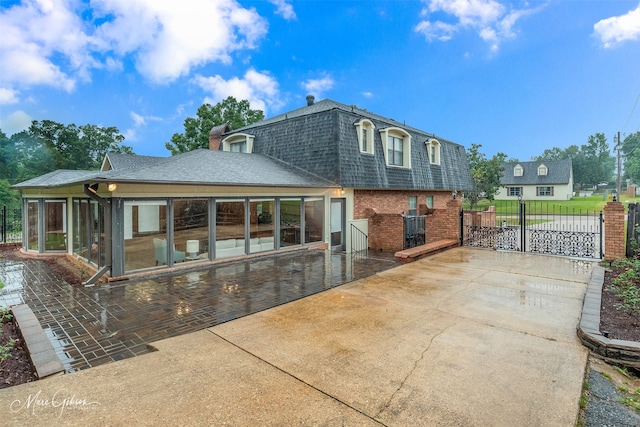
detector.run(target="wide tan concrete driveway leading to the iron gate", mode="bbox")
[0,248,592,426]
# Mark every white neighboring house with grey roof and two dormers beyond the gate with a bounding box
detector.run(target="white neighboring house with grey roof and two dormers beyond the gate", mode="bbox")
[495,159,573,200]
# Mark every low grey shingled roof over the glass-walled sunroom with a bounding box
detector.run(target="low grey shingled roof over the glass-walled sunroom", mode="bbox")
[14,149,335,189]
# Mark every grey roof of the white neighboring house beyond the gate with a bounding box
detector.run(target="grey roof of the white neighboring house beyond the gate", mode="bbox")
[500,159,572,185]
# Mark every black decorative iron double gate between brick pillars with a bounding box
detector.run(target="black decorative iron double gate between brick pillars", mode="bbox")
[460,201,603,259]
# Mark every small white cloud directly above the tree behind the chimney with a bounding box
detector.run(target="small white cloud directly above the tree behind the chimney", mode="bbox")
[193,68,283,114]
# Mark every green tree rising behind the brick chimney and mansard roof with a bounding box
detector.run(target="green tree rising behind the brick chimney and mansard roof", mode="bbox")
[165,96,264,156]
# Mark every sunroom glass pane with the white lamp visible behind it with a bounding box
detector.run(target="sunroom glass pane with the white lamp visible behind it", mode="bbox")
[173,199,209,261]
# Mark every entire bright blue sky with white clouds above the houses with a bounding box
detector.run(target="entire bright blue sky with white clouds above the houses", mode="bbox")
[0,0,640,160]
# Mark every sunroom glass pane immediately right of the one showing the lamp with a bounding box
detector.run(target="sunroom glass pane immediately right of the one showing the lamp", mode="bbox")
[216,200,245,258]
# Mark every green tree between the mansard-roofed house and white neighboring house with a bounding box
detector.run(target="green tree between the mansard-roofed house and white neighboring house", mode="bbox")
[465,144,507,209]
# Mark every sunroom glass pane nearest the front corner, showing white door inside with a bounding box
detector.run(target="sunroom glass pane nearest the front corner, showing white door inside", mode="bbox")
[124,200,168,271]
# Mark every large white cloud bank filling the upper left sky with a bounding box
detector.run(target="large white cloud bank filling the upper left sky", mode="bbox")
[0,0,270,91]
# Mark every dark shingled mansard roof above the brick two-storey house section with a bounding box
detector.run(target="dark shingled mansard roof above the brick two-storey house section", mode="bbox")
[225,99,473,190]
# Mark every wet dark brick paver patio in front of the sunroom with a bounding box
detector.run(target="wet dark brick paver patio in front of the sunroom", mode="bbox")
[0,250,398,372]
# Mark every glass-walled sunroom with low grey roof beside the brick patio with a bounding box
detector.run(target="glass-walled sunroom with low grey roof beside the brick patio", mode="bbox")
[15,150,340,284]
